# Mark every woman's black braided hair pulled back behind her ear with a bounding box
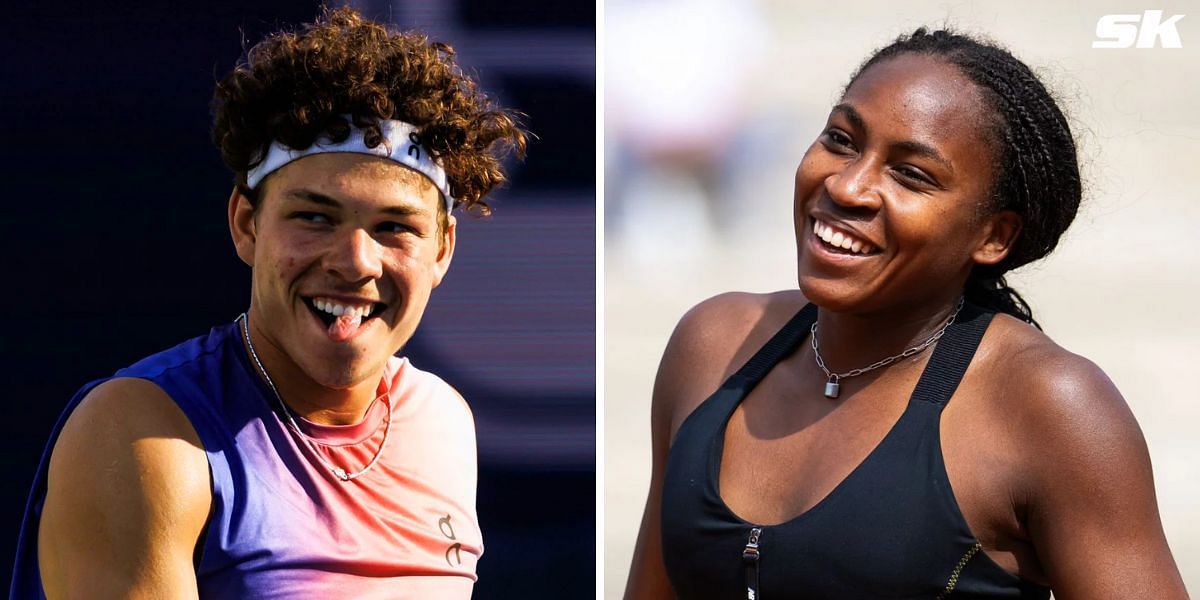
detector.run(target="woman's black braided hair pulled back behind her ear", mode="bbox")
[846,28,1082,329]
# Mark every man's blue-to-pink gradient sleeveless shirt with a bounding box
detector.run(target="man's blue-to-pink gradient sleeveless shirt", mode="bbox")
[10,323,484,599]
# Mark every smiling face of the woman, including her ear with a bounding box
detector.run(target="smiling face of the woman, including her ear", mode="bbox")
[793,54,1020,312]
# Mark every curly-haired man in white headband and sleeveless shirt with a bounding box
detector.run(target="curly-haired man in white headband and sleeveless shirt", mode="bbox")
[12,8,524,599]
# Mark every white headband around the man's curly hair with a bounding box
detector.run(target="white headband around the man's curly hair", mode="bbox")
[246,115,454,214]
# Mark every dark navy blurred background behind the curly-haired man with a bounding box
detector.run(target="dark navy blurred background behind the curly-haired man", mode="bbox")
[0,0,596,599]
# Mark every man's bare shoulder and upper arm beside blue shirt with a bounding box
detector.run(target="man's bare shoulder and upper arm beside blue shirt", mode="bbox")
[38,378,211,598]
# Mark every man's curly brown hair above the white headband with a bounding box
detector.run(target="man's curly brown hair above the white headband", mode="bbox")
[212,7,526,215]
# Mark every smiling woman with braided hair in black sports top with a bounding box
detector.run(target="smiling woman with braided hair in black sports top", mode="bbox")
[626,28,1187,600]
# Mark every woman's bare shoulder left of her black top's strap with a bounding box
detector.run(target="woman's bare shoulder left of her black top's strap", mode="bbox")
[654,290,806,432]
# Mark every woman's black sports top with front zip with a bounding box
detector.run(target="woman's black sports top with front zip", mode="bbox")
[662,304,1050,600]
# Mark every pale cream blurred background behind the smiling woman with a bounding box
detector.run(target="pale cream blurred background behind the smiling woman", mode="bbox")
[604,0,1200,598]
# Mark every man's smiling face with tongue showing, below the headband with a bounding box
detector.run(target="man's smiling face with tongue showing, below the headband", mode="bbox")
[230,154,455,389]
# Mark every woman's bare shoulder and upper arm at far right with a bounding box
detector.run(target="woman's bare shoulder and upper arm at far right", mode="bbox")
[988,317,1187,599]
